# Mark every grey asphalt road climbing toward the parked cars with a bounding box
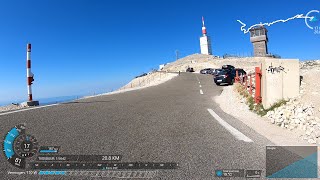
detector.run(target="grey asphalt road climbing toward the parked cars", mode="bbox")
[0,73,272,180]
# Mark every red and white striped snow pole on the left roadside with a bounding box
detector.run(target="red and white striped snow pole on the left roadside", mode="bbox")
[26,44,39,106]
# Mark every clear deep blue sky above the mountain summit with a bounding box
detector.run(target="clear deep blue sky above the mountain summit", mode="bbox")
[0,0,320,104]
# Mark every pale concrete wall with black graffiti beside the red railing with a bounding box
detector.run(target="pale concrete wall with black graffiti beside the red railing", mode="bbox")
[261,58,300,108]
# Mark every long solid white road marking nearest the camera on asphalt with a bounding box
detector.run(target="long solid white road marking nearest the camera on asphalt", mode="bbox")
[208,109,253,142]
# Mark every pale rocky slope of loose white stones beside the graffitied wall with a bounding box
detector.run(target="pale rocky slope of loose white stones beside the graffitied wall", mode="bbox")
[267,60,320,144]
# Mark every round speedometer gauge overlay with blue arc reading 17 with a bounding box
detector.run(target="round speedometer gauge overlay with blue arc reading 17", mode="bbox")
[3,124,39,169]
